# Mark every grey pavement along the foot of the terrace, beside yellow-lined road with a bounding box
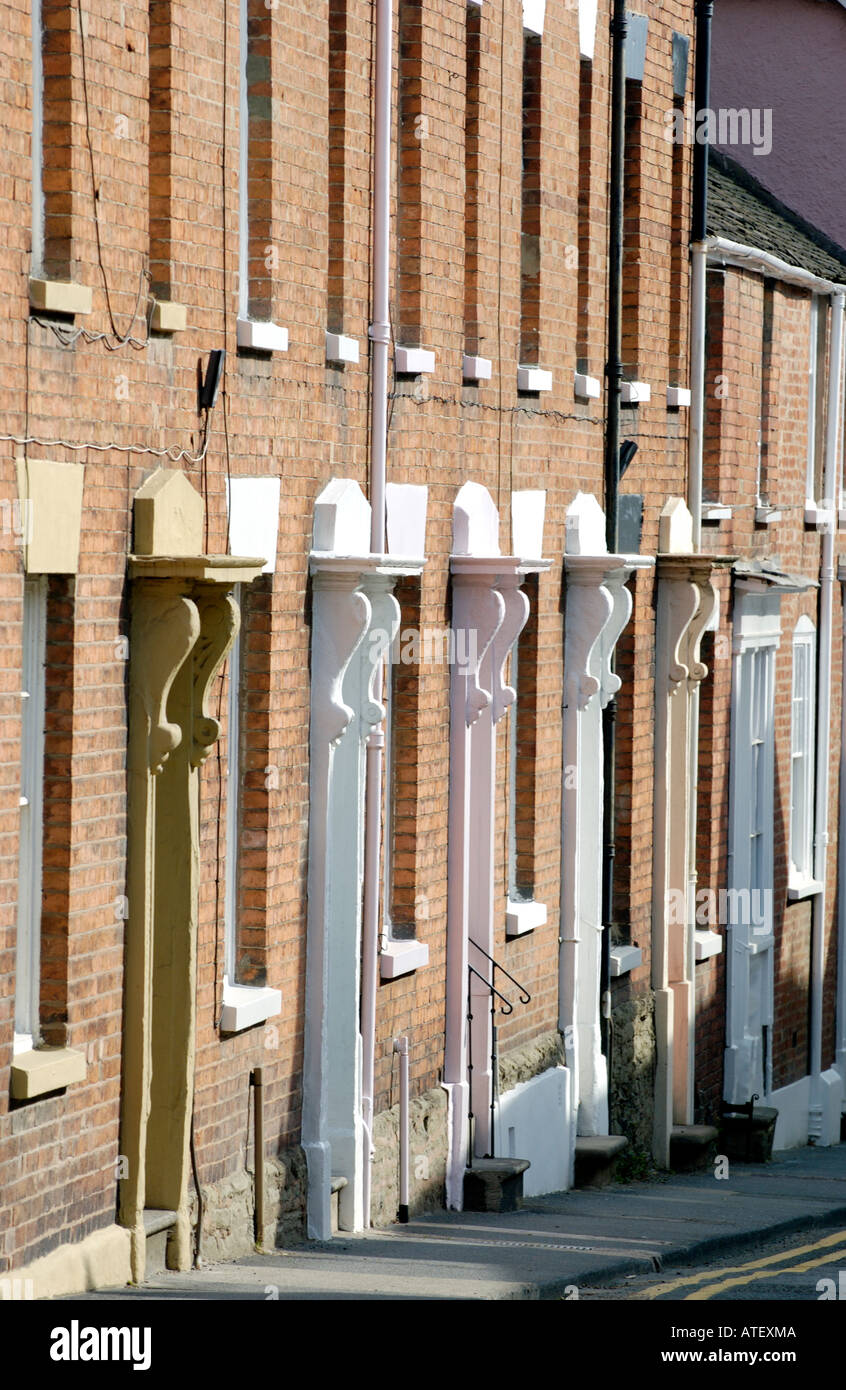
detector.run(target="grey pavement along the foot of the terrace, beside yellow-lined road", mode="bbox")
[83,1144,846,1301]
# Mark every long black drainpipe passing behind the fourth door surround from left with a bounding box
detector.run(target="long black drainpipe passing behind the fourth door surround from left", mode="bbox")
[599,0,628,1083]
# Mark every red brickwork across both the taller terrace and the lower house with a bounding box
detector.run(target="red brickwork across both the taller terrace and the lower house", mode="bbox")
[0,0,840,1273]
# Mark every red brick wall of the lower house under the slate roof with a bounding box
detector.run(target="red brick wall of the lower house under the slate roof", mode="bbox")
[696,270,842,1113]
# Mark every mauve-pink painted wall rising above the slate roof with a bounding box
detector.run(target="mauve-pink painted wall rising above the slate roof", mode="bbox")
[711,0,846,246]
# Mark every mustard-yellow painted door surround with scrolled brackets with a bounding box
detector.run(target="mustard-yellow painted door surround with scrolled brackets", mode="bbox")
[119,468,264,1282]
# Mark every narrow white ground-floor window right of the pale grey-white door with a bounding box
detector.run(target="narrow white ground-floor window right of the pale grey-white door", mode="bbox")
[789,617,820,897]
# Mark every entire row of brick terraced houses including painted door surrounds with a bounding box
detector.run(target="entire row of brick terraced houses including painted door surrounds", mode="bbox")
[0,0,846,1297]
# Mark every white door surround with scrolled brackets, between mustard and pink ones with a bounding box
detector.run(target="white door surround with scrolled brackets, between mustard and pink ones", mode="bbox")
[303,478,424,1240]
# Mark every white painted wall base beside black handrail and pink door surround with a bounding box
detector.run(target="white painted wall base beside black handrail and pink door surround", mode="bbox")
[496,1066,574,1197]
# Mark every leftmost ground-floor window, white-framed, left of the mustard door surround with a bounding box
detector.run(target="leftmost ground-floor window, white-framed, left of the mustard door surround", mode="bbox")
[14,575,47,1052]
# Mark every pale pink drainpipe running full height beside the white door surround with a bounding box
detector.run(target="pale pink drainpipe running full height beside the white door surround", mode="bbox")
[361,0,393,1226]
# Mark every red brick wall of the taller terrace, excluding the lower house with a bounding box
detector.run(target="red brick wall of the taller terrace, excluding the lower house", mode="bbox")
[0,0,705,1268]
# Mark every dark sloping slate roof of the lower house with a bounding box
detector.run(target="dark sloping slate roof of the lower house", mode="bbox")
[708,150,846,284]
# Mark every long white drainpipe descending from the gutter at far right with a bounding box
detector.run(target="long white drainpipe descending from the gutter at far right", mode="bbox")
[808,289,846,1141]
